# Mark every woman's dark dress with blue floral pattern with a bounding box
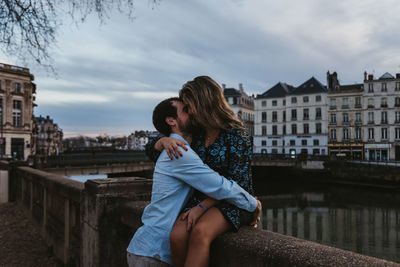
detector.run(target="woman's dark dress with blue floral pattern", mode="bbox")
[146,128,254,231]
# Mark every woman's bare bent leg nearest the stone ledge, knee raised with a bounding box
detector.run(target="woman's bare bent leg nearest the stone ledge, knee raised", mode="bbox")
[185,208,231,267]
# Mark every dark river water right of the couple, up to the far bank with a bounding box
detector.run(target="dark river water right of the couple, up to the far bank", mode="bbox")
[256,181,400,262]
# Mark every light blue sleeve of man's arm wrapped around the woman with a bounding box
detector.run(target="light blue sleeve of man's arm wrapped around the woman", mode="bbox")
[158,149,257,212]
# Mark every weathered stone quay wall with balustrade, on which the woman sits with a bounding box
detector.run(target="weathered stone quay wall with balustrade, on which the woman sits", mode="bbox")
[0,162,400,267]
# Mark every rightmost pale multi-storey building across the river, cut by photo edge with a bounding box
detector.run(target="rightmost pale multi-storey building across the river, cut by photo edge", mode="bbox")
[363,72,400,161]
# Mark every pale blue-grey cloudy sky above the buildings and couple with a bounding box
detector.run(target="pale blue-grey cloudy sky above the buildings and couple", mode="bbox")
[0,0,400,136]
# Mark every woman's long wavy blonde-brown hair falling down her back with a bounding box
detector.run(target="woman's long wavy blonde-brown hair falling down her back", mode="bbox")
[179,76,244,130]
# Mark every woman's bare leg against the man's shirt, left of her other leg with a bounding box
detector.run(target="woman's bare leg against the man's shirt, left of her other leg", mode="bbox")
[169,213,190,267]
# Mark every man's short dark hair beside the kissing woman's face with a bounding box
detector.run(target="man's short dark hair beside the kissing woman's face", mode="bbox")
[153,97,181,136]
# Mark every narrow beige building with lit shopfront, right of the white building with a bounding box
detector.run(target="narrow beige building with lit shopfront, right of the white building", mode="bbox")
[327,72,364,159]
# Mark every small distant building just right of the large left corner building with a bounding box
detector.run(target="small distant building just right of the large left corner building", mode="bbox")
[34,116,63,156]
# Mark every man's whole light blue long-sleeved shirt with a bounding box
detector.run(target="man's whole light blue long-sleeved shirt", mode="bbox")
[127,134,257,265]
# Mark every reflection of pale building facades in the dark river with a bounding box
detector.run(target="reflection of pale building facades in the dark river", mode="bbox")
[260,193,400,262]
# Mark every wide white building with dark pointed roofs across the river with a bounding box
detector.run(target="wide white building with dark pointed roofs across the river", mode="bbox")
[254,77,328,155]
